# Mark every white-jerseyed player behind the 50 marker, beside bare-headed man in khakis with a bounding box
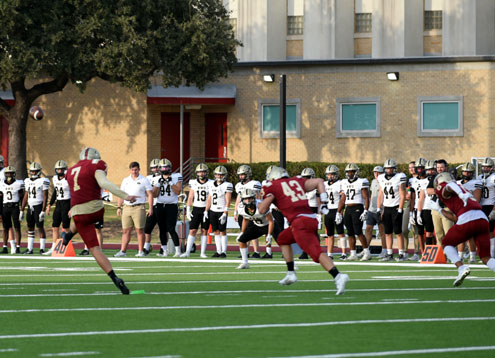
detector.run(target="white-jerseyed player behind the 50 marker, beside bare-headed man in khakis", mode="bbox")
[416,160,437,250]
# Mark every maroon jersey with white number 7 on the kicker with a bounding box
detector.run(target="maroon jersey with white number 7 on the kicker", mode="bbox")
[67,159,107,207]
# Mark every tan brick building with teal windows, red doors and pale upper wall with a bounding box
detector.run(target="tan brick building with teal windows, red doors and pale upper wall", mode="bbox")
[0,0,495,182]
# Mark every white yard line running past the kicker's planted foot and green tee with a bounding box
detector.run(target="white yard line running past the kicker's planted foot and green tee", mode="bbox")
[0,282,495,298]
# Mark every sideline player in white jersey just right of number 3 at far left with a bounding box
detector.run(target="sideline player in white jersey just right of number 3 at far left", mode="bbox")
[19,162,50,255]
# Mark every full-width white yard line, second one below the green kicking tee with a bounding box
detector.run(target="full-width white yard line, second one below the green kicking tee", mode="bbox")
[0,316,495,340]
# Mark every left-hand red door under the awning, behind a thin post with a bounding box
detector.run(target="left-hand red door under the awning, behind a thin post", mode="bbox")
[161,113,190,171]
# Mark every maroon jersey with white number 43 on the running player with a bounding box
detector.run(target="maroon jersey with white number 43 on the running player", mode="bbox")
[263,177,313,223]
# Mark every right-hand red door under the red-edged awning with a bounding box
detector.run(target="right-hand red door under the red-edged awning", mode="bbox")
[205,113,227,163]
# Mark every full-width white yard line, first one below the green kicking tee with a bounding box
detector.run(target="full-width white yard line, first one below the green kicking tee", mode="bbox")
[0,296,495,313]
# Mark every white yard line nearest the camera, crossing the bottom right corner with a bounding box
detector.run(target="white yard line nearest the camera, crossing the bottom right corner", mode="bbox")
[264,346,495,358]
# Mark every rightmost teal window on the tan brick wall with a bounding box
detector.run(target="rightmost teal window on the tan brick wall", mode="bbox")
[418,96,464,137]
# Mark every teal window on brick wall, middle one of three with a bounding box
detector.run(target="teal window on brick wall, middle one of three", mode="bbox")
[336,97,381,138]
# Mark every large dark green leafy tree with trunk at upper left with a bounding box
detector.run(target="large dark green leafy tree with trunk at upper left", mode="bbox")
[0,0,239,175]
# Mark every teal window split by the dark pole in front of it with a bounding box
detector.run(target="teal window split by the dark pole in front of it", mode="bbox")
[258,99,301,138]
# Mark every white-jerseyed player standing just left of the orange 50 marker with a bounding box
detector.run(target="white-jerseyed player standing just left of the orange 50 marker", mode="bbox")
[409,158,431,261]
